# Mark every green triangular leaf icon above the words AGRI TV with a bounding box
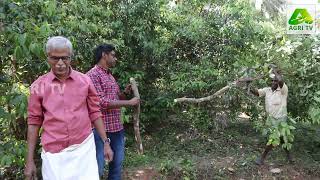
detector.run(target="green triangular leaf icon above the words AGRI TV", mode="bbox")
[289,8,313,25]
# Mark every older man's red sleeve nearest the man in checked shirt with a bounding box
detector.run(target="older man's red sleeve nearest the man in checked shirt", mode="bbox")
[87,79,102,122]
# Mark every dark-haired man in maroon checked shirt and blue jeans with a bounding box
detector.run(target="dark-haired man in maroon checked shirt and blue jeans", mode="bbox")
[87,44,140,180]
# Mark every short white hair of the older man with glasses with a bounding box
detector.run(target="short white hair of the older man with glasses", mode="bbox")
[46,36,73,54]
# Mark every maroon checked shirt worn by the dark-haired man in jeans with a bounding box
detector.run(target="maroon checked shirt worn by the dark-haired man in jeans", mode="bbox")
[87,65,123,132]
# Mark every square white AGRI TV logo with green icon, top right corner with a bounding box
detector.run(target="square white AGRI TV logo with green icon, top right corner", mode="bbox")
[287,5,316,34]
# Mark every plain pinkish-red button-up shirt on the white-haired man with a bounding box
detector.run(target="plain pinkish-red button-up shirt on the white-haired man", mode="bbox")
[28,69,101,153]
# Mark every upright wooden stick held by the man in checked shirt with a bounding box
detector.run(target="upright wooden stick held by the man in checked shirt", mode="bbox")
[130,78,143,154]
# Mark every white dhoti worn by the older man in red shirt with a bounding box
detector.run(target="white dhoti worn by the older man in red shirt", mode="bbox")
[41,133,99,180]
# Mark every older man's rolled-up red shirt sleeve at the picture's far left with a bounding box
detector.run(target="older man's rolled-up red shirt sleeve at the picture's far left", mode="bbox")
[28,84,43,126]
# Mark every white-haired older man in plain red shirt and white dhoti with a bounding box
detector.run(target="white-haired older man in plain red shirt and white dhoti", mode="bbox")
[25,36,113,180]
